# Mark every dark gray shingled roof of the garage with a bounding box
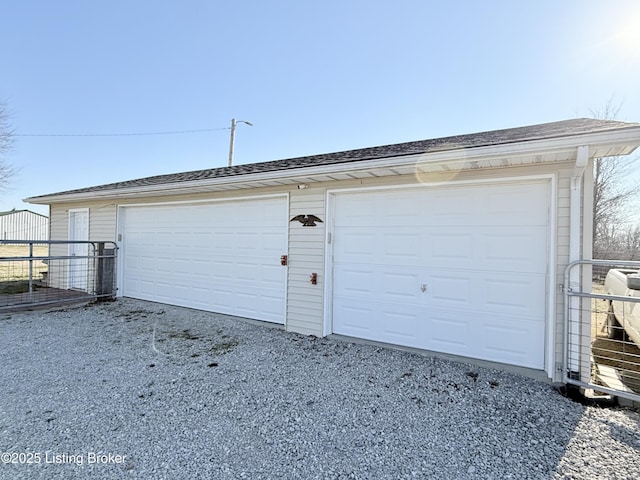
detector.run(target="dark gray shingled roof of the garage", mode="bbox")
[25,118,640,200]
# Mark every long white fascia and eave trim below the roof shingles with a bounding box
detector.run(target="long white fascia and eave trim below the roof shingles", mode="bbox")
[25,126,640,204]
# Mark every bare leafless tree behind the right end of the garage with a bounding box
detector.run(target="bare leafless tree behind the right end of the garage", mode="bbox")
[591,99,639,260]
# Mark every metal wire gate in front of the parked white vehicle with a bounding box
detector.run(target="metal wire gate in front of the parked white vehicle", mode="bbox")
[564,260,640,402]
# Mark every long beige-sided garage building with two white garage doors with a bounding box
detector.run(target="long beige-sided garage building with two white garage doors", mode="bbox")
[27,119,640,381]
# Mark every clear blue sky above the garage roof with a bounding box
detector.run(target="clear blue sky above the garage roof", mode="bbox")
[0,0,640,213]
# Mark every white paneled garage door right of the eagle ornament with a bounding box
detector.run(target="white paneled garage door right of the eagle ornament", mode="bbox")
[332,182,550,369]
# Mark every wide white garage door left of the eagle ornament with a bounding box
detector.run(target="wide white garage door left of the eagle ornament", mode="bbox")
[121,197,288,323]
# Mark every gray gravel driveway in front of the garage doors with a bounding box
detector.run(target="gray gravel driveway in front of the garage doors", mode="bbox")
[0,299,640,479]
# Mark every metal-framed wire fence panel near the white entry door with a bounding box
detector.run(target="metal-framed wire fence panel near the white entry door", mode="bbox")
[0,240,117,310]
